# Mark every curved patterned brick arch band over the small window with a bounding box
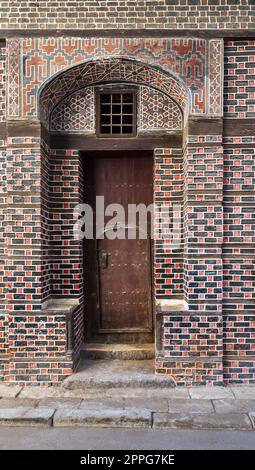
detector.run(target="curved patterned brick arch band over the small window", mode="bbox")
[39,58,190,129]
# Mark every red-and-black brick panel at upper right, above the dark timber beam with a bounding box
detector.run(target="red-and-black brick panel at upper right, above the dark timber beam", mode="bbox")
[224,41,255,119]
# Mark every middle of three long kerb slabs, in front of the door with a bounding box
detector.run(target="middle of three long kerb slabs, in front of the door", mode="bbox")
[53,408,151,428]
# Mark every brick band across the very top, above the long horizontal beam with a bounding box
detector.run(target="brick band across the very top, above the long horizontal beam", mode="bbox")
[0,0,255,32]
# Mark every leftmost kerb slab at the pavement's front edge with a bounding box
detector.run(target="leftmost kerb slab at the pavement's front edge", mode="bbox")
[0,407,55,426]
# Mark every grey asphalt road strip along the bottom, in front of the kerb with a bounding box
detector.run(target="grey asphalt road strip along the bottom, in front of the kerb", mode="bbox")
[0,427,255,450]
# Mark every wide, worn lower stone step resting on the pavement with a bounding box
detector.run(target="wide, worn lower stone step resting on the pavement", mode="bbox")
[62,359,175,393]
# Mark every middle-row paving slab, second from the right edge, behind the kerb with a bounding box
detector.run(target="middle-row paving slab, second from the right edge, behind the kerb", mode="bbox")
[167,398,214,414]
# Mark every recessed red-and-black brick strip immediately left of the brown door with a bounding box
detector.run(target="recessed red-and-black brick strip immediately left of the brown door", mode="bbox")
[49,150,83,297]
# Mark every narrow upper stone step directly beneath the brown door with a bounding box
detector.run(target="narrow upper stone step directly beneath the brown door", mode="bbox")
[81,343,155,361]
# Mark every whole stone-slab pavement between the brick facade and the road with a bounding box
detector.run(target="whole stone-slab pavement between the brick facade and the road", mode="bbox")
[0,379,255,432]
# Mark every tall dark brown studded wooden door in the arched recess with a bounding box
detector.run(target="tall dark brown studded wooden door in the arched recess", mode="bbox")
[84,152,153,343]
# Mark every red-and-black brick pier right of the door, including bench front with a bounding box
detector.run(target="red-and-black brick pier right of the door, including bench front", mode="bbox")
[156,134,223,385]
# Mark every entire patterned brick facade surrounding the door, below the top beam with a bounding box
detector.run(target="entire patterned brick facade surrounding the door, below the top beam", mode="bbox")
[0,35,255,385]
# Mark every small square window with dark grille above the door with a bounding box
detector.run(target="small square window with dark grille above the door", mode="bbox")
[97,89,136,138]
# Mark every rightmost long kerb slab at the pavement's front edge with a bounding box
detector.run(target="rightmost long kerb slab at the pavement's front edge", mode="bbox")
[153,413,252,430]
